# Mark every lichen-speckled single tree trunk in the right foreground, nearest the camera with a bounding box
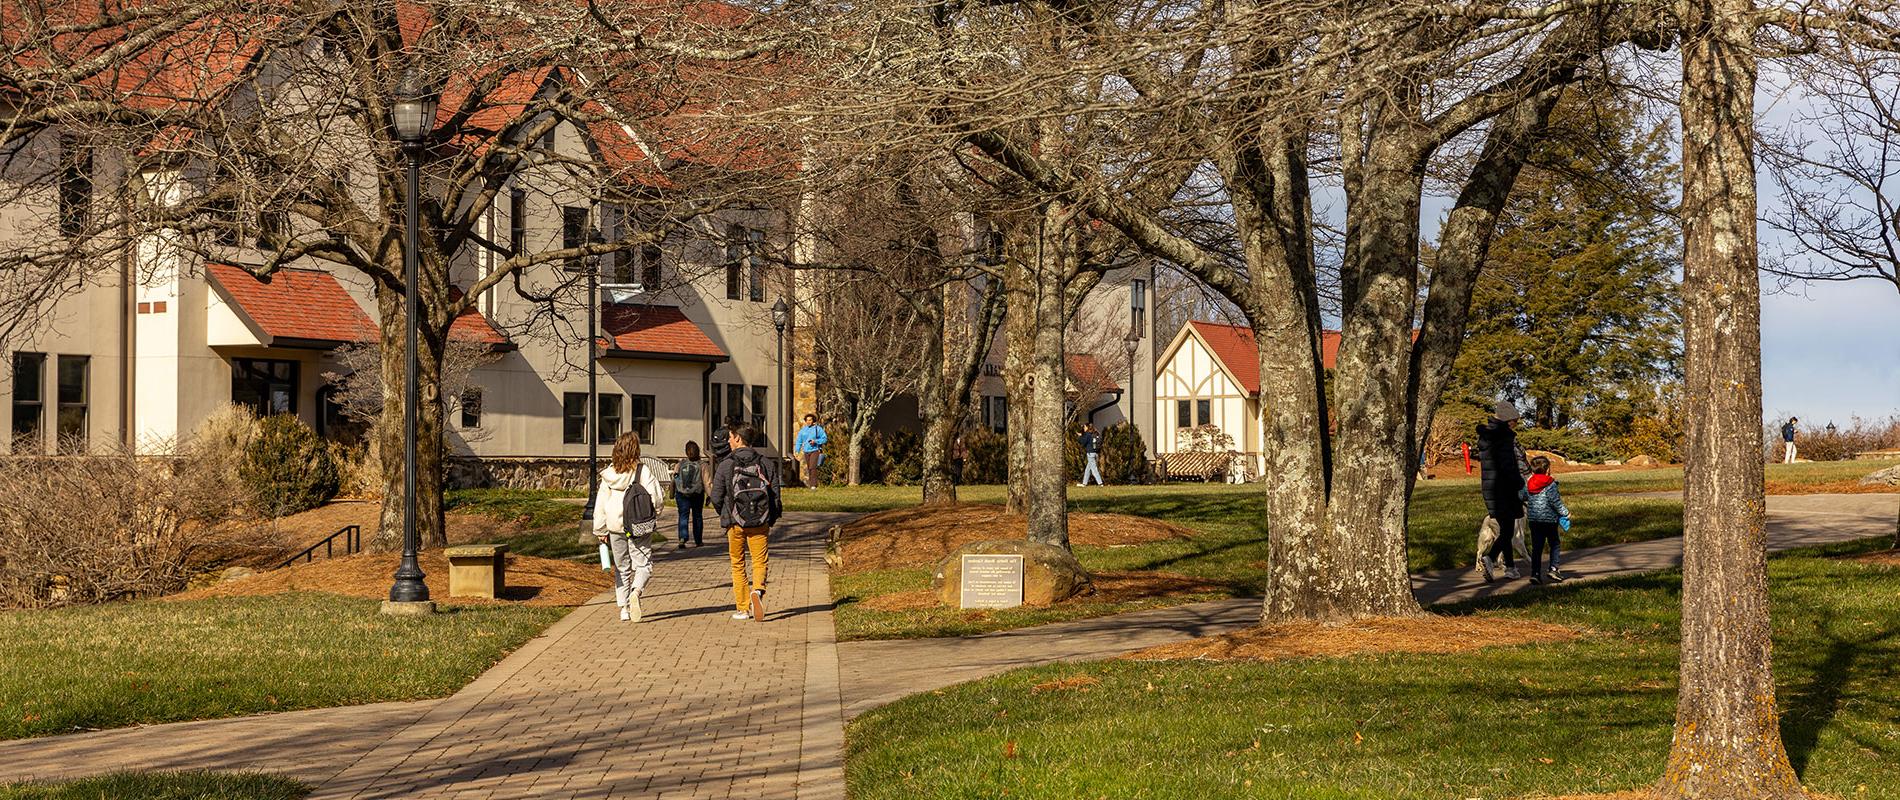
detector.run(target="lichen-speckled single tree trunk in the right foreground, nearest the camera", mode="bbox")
[1657,0,1803,800]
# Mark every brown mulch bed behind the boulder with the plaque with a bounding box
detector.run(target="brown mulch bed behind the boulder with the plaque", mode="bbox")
[838,505,1193,572]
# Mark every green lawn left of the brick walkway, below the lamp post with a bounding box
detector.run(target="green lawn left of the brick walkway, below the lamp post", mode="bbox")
[0,593,568,739]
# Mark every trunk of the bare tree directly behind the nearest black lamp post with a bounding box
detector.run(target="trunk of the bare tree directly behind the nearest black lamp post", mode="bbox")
[371,285,448,551]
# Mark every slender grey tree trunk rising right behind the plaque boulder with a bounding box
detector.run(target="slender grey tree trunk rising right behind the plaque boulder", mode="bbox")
[1026,203,1075,549]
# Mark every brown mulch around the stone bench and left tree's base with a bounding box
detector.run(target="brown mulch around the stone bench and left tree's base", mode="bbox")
[165,549,614,606]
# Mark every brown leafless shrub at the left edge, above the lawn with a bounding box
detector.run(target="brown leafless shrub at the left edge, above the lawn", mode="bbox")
[0,452,251,608]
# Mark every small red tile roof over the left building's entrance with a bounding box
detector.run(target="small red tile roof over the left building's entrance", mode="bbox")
[205,264,376,346]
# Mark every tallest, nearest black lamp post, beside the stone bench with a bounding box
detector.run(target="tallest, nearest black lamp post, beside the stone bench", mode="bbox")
[390,68,437,608]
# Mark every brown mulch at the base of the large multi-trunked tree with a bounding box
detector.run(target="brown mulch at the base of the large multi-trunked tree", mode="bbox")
[1123,616,1583,661]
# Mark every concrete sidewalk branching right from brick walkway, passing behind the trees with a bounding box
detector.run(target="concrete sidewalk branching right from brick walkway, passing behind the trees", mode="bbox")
[838,494,1900,716]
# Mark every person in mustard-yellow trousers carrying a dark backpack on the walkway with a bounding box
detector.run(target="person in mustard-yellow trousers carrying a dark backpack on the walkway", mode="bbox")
[711,424,781,621]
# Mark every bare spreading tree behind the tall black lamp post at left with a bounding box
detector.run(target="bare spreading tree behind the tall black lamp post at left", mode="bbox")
[0,0,783,545]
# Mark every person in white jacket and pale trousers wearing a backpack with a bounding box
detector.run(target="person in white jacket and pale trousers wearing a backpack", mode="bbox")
[595,431,667,621]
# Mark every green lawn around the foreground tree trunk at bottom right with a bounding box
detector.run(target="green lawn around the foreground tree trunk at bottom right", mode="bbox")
[846,543,1900,800]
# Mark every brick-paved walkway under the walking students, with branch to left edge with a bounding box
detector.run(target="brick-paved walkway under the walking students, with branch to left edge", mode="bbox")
[0,513,844,800]
